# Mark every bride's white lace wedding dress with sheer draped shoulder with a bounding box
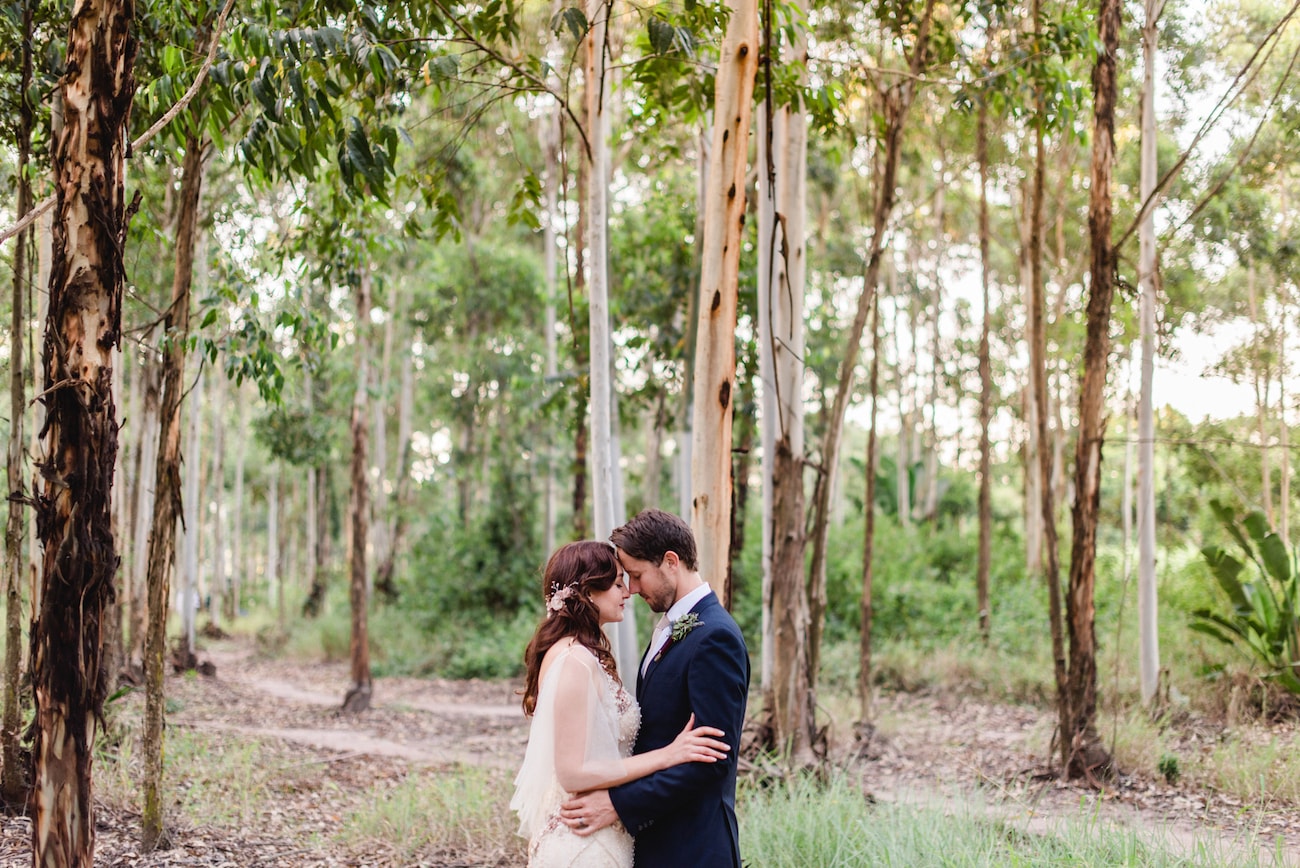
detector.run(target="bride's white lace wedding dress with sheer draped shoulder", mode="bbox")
[510,645,641,868]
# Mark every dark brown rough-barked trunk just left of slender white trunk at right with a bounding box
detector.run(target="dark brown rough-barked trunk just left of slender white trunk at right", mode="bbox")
[1061,0,1121,780]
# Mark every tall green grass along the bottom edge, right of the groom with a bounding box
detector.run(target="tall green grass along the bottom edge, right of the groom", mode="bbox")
[737,777,1274,868]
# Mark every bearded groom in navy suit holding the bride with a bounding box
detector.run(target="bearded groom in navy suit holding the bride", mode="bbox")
[560,509,749,868]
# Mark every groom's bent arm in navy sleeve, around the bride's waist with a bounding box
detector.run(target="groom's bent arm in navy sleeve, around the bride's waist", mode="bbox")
[610,629,749,834]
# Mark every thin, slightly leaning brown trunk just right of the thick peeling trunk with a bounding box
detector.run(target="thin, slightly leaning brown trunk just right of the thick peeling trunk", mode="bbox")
[140,133,203,850]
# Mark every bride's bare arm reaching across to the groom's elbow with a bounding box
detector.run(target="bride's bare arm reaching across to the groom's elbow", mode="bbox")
[555,654,731,793]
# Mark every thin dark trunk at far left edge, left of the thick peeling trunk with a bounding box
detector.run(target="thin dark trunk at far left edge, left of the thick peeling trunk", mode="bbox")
[0,1,35,807]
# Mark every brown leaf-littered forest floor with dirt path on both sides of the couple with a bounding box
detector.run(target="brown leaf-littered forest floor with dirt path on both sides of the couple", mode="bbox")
[0,641,1300,868]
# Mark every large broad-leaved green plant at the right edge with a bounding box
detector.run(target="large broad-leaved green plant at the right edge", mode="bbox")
[1192,500,1300,693]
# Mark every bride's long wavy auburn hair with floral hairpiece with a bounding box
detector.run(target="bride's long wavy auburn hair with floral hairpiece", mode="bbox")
[524,539,619,715]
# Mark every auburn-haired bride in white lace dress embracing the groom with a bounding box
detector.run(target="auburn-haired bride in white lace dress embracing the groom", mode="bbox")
[510,541,731,868]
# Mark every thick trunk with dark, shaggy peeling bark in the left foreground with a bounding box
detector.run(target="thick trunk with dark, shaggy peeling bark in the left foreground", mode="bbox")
[30,0,135,868]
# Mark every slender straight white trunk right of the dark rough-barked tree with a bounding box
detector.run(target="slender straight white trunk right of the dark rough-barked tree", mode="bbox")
[1138,0,1164,704]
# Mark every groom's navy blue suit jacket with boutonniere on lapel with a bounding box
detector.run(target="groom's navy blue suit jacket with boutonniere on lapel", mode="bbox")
[610,594,749,868]
